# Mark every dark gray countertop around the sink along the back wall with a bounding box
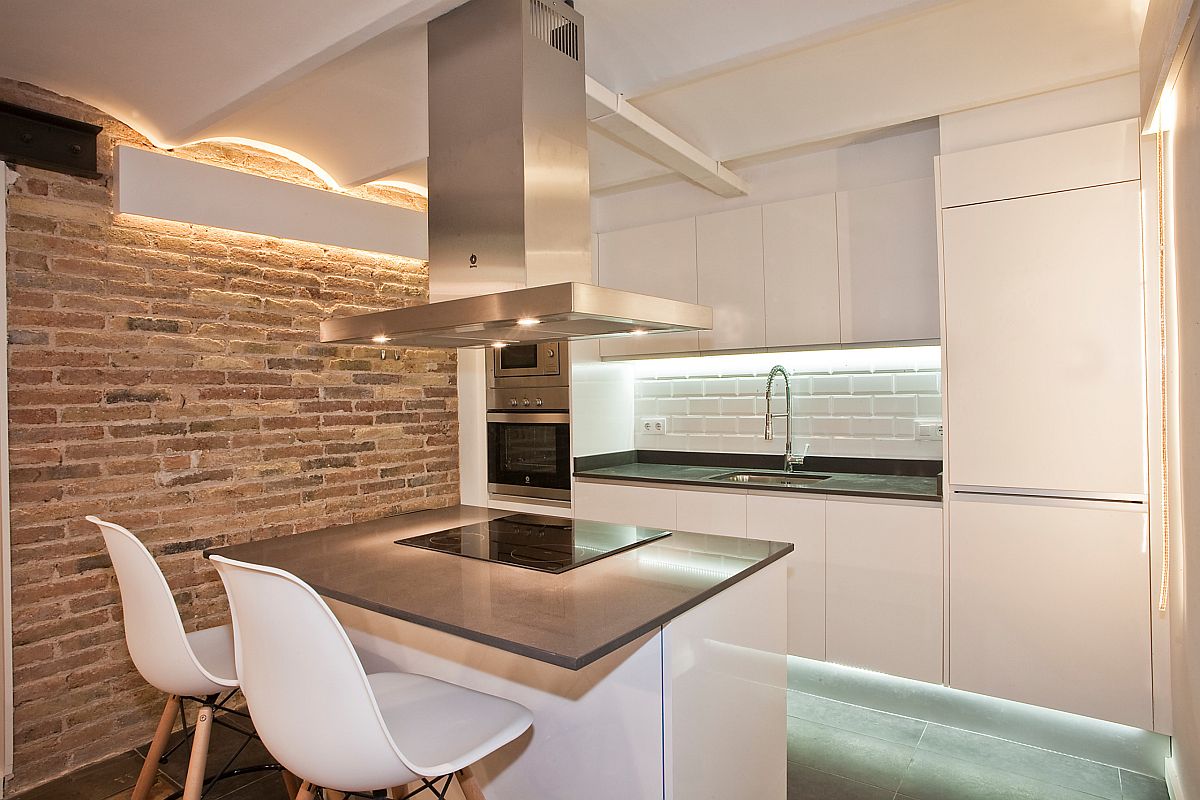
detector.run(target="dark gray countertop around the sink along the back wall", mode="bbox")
[575,462,942,503]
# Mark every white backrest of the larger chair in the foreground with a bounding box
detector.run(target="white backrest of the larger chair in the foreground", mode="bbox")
[211,555,415,790]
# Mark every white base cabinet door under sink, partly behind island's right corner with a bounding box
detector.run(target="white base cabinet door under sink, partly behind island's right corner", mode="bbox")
[746,493,826,661]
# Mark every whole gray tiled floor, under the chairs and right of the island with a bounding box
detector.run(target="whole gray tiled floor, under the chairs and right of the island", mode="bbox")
[9,691,1168,800]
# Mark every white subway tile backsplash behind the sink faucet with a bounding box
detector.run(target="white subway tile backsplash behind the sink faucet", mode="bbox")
[635,348,942,458]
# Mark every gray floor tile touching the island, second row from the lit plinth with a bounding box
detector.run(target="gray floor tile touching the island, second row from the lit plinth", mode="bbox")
[787,717,916,792]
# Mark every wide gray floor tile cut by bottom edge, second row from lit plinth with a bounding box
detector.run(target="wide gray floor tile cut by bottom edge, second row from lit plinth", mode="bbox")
[899,750,1123,800]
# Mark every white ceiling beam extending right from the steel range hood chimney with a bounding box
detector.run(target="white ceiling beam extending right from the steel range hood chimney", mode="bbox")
[587,76,750,197]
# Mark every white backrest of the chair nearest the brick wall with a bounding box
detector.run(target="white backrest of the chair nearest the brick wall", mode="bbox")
[88,517,236,696]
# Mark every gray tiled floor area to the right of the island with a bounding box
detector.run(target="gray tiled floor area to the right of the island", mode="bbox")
[787,691,1168,800]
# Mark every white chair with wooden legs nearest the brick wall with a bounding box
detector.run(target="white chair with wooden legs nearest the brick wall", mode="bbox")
[88,517,255,800]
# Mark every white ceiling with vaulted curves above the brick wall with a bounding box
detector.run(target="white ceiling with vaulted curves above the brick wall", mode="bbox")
[0,0,1144,192]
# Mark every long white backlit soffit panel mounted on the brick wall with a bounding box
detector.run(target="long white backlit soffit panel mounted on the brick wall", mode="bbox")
[116,145,428,260]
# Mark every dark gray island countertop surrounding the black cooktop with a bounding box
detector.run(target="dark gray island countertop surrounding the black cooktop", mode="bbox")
[205,506,793,669]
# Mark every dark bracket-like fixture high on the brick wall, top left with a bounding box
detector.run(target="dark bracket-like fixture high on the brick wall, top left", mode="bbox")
[0,103,102,178]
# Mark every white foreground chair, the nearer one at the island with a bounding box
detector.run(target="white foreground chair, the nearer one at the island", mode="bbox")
[211,555,533,800]
